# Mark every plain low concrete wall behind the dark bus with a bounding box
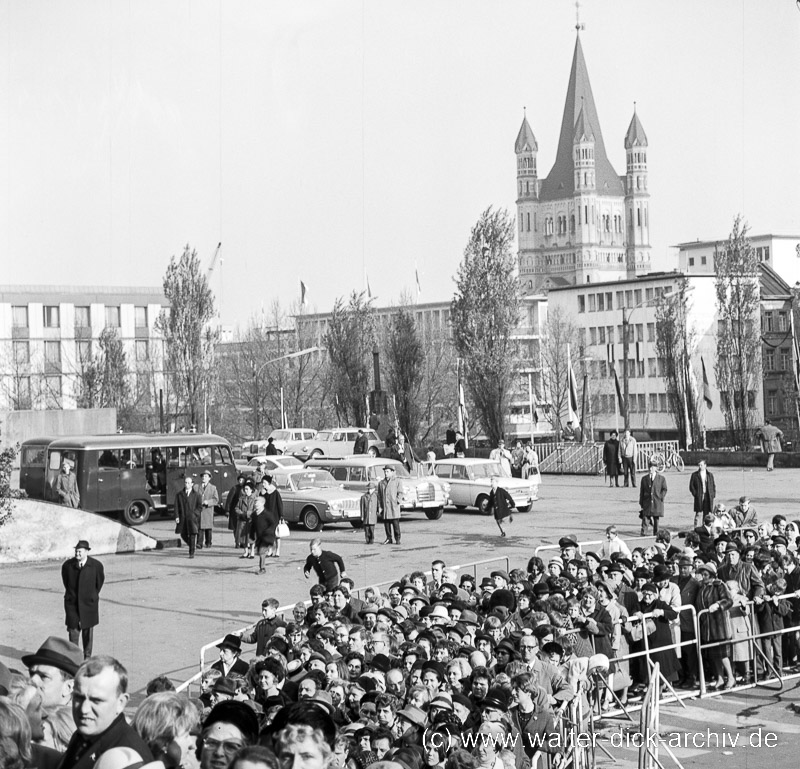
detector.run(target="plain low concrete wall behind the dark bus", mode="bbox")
[0,409,117,446]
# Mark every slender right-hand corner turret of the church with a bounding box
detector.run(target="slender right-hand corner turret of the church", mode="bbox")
[625,105,650,274]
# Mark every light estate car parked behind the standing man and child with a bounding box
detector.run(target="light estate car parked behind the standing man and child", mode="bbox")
[306,455,450,521]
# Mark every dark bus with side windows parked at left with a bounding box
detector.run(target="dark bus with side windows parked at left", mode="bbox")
[19,433,237,526]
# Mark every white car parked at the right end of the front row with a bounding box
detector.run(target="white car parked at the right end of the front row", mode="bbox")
[434,458,537,513]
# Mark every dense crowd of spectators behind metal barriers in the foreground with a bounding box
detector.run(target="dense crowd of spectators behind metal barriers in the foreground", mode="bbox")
[6,498,800,769]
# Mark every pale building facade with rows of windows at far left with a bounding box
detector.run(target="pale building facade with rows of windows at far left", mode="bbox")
[0,286,169,410]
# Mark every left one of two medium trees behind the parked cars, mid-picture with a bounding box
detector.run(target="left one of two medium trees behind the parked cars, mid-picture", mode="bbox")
[325,291,375,425]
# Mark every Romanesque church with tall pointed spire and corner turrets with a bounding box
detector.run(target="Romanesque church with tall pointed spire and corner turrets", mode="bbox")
[514,32,651,292]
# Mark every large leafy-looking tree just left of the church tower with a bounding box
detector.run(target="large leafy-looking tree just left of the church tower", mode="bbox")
[450,207,521,445]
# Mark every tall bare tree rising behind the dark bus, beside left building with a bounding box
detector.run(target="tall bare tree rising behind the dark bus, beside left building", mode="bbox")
[156,245,219,429]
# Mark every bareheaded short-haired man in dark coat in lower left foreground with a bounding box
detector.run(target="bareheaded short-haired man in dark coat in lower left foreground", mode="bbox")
[58,656,153,769]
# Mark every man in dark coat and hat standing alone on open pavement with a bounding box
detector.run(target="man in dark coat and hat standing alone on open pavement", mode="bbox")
[61,539,106,657]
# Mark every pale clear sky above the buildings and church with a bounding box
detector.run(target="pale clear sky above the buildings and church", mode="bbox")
[0,0,800,326]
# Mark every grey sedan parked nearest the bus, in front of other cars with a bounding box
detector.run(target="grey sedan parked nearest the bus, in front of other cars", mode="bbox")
[272,468,361,531]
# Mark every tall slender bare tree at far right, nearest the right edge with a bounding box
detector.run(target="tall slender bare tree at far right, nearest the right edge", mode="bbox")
[714,216,762,448]
